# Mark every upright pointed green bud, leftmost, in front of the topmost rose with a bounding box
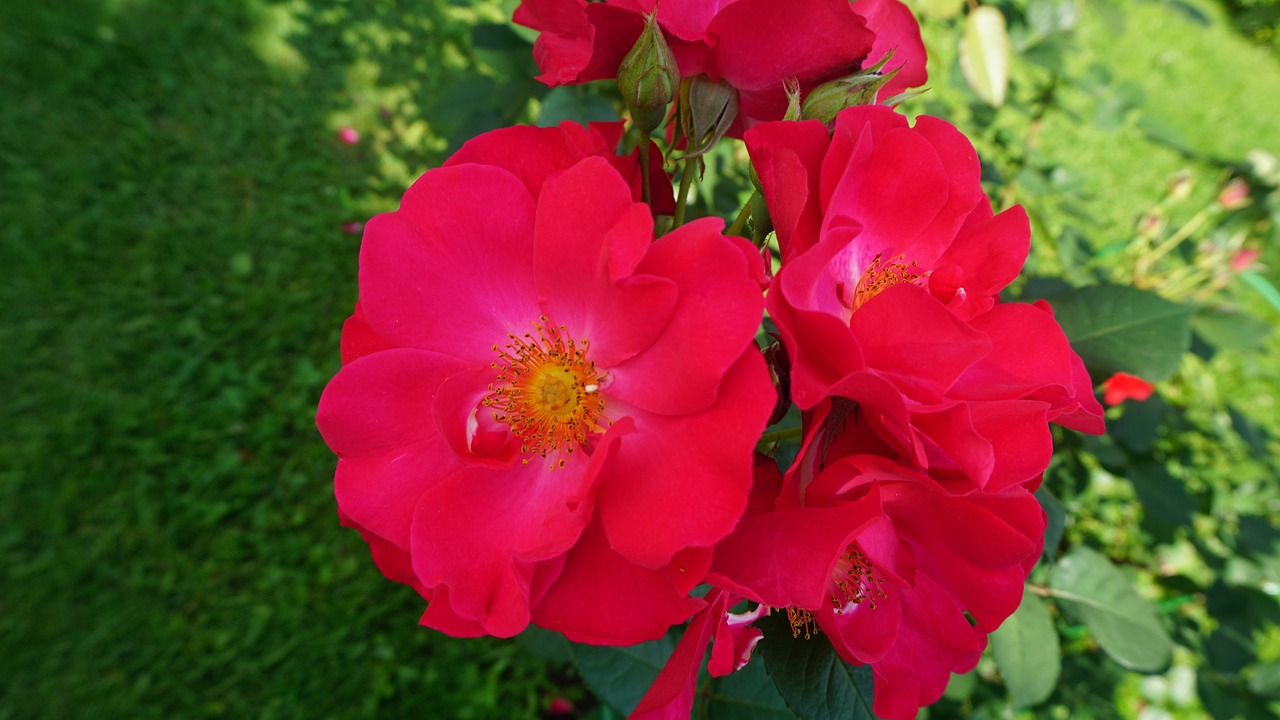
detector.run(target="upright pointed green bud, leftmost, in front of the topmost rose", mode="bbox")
[618,14,680,135]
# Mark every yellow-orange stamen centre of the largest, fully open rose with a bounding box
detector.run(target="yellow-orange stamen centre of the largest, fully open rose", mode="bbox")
[481,316,608,470]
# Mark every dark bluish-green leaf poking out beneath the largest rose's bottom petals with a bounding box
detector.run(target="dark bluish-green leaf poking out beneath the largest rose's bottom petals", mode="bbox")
[570,635,676,714]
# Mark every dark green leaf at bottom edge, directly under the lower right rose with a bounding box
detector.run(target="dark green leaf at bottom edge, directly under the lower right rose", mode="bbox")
[758,612,876,720]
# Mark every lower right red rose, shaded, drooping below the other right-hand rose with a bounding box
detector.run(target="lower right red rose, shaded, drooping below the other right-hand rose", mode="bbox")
[704,450,1044,719]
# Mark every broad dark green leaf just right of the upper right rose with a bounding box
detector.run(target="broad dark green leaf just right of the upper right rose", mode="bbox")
[1053,284,1192,382]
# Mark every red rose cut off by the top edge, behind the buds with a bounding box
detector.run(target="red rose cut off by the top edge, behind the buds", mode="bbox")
[515,0,925,128]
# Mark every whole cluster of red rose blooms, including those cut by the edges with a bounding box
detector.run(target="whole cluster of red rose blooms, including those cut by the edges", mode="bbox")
[317,0,1102,719]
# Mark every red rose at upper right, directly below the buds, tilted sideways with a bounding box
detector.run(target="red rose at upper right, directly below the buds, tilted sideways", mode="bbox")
[745,106,1102,491]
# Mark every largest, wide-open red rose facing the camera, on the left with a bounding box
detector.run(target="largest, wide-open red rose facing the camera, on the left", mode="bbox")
[316,124,773,644]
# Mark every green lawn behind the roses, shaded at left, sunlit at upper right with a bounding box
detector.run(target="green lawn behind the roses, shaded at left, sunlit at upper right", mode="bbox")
[0,0,1280,720]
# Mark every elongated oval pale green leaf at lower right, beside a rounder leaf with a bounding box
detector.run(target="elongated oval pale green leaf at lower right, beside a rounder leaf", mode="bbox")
[1050,546,1172,673]
